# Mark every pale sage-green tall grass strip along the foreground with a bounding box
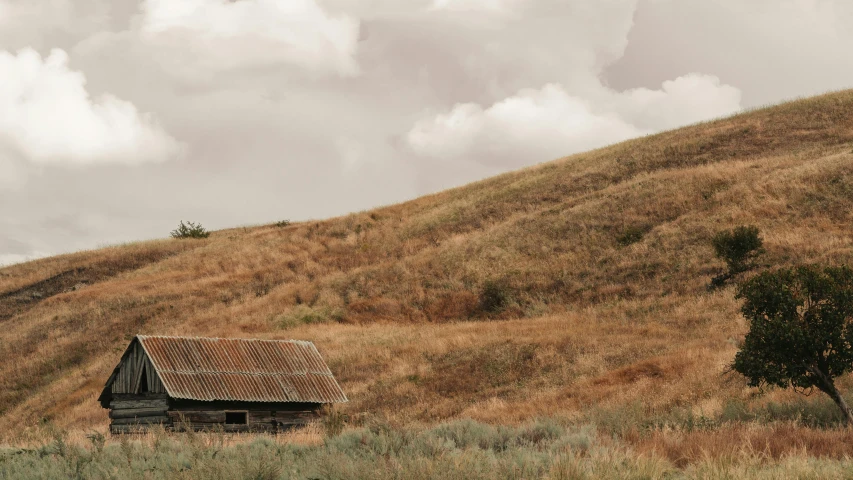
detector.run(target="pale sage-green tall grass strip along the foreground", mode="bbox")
[5,419,853,480]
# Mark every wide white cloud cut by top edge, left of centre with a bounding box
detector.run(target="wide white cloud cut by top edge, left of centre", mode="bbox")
[142,0,359,75]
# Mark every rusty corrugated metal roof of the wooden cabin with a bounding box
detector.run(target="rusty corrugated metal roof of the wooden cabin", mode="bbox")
[136,335,347,403]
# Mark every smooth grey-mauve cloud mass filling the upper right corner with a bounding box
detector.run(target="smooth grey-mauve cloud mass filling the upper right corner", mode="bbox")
[605,0,853,106]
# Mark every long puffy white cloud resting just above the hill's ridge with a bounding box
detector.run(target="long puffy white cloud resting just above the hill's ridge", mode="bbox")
[406,74,741,168]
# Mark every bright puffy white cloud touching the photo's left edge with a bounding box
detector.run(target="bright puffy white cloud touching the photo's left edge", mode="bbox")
[0,49,181,168]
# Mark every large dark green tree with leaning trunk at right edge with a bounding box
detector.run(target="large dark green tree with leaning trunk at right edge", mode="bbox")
[732,265,853,425]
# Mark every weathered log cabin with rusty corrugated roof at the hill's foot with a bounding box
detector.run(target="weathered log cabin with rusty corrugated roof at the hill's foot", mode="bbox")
[98,335,347,433]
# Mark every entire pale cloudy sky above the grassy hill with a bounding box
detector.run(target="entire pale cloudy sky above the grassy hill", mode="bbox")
[0,0,853,265]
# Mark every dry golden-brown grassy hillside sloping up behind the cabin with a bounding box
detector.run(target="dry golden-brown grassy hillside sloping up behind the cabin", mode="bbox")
[0,87,853,446]
